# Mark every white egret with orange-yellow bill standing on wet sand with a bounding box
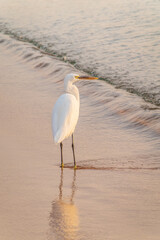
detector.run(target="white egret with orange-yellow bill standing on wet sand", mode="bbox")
[52,73,97,168]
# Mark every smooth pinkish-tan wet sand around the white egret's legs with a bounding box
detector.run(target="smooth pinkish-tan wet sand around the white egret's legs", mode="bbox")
[0,40,160,240]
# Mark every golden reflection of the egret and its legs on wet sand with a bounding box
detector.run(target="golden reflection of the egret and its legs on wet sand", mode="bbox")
[48,169,79,240]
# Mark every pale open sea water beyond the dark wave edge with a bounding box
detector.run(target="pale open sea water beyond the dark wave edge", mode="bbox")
[0,0,160,105]
